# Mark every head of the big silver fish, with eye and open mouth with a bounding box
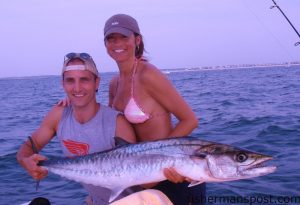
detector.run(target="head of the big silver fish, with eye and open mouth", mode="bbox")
[201,144,276,181]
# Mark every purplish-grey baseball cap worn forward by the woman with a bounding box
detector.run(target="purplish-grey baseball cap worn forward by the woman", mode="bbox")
[104,14,140,38]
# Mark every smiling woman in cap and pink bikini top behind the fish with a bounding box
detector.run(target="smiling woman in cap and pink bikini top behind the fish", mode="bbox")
[104,14,205,205]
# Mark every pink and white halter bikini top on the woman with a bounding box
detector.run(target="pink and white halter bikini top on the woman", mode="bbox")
[124,60,150,124]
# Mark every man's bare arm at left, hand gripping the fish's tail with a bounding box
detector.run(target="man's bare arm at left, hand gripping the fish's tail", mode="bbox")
[17,106,63,180]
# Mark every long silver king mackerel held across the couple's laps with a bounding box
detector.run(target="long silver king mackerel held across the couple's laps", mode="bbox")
[40,137,276,202]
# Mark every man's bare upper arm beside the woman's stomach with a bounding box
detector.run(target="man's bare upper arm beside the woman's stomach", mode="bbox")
[115,114,137,143]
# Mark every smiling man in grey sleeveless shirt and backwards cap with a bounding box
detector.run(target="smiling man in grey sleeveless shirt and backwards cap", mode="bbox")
[17,53,136,205]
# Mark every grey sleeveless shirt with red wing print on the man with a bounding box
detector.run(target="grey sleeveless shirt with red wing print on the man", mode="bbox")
[57,105,119,205]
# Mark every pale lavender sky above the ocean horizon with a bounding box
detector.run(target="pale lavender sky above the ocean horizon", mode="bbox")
[0,0,300,78]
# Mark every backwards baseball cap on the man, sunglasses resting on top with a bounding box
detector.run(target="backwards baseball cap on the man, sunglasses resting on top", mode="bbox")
[62,53,99,76]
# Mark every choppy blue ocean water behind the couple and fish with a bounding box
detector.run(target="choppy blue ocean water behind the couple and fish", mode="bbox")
[0,66,300,205]
